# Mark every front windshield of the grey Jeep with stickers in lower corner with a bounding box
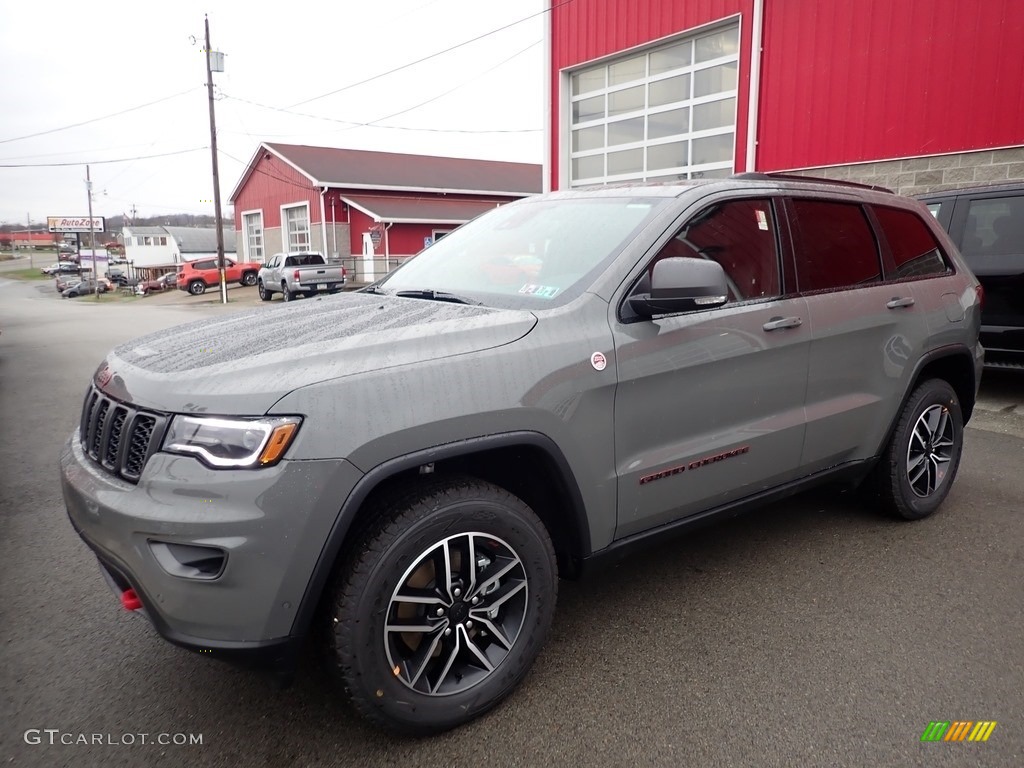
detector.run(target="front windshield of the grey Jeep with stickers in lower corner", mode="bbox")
[379,198,666,308]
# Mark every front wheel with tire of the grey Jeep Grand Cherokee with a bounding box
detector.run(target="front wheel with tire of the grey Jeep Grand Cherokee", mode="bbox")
[326,478,558,735]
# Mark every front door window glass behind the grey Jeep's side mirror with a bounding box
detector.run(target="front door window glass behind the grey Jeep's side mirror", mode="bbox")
[648,199,781,302]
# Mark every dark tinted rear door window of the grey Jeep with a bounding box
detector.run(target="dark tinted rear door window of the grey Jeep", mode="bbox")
[791,200,882,293]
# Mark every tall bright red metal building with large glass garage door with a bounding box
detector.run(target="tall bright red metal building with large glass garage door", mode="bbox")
[545,0,1024,194]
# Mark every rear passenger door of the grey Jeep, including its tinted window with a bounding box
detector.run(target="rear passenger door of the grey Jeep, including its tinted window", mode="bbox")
[786,196,928,474]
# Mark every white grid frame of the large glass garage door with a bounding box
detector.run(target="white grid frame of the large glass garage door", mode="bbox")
[559,16,742,188]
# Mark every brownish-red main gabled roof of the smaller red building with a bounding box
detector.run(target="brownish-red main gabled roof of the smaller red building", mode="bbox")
[230,142,542,201]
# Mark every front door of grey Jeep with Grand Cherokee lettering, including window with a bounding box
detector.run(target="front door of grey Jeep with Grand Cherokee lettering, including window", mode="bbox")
[612,197,810,538]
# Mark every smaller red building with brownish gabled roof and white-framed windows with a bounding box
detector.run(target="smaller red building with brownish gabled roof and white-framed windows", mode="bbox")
[229,143,541,282]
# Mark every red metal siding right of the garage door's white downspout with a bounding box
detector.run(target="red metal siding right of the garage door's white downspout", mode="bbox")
[757,0,1024,170]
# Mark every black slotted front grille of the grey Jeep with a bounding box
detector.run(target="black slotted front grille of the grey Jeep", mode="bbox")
[81,387,167,482]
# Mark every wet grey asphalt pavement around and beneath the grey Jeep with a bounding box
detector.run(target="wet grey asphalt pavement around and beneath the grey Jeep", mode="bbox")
[0,273,1024,768]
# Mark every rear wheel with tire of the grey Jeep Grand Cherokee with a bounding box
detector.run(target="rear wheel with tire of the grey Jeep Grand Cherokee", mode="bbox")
[872,379,964,520]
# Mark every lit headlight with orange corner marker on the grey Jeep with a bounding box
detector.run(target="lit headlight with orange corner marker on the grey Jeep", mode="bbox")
[162,416,302,469]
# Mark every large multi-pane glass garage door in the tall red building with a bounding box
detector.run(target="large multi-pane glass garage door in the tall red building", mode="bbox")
[568,24,739,186]
